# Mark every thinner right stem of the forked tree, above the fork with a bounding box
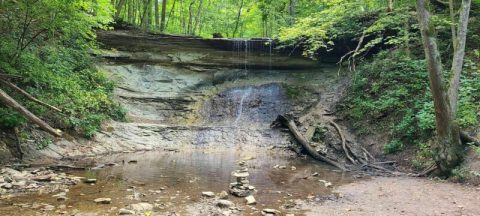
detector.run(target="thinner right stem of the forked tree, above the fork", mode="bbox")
[448,0,472,114]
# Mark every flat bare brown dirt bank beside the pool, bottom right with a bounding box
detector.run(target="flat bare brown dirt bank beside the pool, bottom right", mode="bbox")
[303,177,480,216]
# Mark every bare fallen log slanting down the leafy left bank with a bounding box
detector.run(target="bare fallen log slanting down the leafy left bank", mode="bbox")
[0,89,62,137]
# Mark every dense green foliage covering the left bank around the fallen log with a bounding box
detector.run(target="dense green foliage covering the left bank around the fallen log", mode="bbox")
[0,0,125,137]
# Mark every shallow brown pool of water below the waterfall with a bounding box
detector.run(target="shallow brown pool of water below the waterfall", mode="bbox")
[0,146,352,215]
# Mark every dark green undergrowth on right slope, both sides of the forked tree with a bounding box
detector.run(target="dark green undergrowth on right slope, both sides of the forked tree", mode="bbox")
[341,50,480,154]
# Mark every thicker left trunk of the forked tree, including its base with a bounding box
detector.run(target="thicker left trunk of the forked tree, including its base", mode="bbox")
[417,0,468,174]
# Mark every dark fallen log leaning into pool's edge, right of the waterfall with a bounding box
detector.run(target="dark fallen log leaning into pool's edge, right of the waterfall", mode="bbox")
[276,115,348,171]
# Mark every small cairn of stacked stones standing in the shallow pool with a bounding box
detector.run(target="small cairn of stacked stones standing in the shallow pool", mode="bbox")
[229,161,255,197]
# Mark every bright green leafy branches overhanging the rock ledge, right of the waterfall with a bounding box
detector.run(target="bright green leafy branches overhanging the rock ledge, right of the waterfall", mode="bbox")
[279,0,416,58]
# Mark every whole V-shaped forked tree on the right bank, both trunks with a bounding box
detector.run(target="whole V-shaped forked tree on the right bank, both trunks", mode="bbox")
[416,0,471,174]
